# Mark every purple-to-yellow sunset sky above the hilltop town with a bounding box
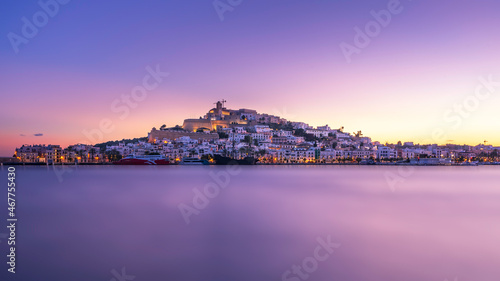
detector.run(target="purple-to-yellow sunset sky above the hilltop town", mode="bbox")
[0,0,500,156]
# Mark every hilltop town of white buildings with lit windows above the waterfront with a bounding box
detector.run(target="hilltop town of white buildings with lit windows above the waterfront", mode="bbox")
[10,100,500,164]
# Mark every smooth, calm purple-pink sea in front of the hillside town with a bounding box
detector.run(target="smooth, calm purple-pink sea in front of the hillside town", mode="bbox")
[0,166,500,281]
